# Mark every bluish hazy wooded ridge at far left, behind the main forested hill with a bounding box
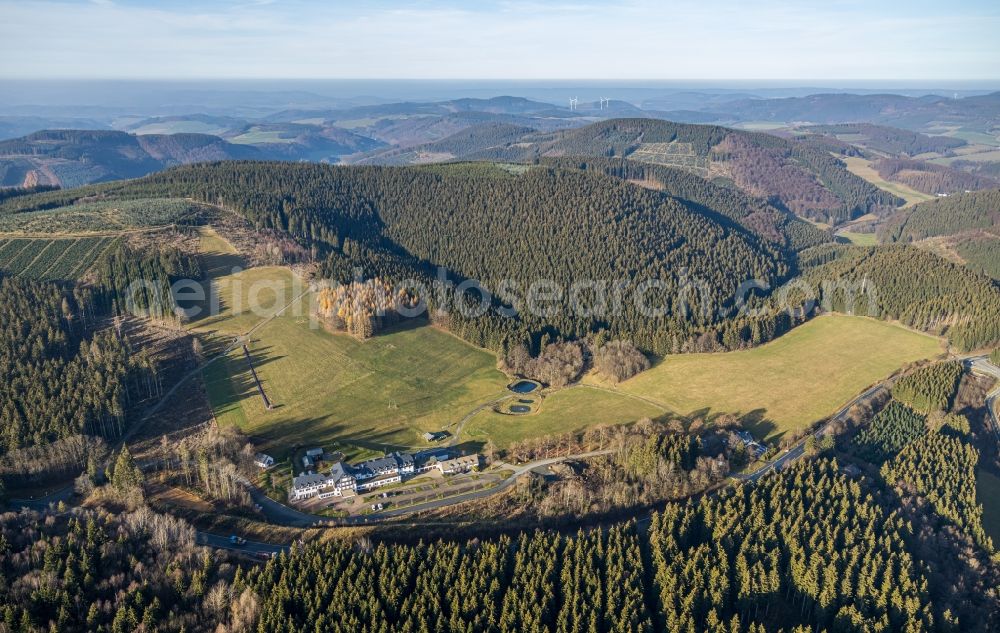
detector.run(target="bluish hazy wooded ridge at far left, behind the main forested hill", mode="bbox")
[0,130,264,187]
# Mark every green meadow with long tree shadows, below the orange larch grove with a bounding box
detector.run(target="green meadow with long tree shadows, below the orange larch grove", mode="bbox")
[205,316,507,458]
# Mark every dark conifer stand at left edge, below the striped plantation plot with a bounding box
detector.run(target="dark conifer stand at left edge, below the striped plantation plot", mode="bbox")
[0,276,157,452]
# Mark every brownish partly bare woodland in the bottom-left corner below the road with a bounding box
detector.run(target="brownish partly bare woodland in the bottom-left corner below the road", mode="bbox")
[0,508,223,633]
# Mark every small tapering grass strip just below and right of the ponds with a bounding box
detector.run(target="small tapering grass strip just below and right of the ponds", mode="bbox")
[460,386,665,448]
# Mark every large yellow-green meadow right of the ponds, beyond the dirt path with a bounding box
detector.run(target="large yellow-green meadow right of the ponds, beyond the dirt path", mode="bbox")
[612,315,942,437]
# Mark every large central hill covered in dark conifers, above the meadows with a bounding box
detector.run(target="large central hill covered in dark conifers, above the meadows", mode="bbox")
[29,162,792,352]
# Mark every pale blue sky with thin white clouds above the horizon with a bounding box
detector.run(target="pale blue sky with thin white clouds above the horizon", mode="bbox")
[0,0,1000,81]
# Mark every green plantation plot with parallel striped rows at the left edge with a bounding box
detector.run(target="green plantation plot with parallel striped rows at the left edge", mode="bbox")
[0,237,115,280]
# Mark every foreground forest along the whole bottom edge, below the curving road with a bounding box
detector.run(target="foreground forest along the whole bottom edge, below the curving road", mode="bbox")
[9,454,997,633]
